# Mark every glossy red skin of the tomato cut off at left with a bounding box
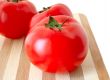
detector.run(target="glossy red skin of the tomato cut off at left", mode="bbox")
[0,1,37,39]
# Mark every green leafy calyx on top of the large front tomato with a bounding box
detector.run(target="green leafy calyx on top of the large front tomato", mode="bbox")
[45,16,65,30]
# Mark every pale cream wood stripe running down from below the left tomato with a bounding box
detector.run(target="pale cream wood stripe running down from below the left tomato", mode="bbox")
[3,39,24,80]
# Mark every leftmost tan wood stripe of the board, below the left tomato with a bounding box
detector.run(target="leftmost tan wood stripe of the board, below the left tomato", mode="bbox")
[0,38,13,80]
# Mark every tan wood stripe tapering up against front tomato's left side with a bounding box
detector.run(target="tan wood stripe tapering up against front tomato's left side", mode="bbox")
[16,44,30,80]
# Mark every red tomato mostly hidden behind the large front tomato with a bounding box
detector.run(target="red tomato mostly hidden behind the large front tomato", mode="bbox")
[30,4,72,28]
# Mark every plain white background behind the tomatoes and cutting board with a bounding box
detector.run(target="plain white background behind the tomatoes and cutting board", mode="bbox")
[30,0,110,76]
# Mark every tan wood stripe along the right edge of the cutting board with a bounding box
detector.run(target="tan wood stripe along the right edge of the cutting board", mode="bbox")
[79,14,109,80]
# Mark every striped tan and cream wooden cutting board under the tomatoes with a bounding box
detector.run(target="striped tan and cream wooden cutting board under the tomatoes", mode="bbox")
[0,14,109,80]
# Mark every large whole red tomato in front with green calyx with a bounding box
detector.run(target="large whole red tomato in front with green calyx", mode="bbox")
[24,15,88,73]
